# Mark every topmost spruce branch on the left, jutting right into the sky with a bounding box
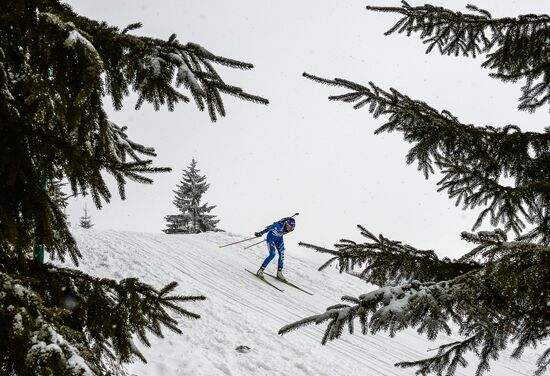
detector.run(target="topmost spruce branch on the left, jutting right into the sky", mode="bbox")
[41,7,268,121]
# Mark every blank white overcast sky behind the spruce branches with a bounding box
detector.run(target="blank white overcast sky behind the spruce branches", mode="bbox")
[63,0,548,257]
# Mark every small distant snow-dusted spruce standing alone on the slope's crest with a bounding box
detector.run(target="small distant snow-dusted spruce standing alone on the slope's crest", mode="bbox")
[163,159,219,234]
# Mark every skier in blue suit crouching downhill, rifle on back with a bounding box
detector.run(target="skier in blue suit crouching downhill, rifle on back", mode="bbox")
[254,217,296,281]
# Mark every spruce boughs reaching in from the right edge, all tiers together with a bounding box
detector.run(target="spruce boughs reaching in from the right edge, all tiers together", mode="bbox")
[280,2,550,375]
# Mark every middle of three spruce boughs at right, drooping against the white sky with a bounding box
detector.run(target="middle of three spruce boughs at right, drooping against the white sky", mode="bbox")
[304,73,550,244]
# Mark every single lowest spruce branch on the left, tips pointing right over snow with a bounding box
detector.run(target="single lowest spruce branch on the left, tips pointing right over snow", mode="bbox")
[28,265,205,362]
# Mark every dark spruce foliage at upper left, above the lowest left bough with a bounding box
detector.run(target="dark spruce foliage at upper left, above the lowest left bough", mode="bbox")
[0,0,267,259]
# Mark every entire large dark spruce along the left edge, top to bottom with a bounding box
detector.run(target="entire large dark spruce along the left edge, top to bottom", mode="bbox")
[0,0,267,375]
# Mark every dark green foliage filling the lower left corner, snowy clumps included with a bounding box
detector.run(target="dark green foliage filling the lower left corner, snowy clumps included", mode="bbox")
[0,262,204,375]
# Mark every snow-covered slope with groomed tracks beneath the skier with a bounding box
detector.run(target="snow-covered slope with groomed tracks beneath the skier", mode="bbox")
[63,230,536,376]
